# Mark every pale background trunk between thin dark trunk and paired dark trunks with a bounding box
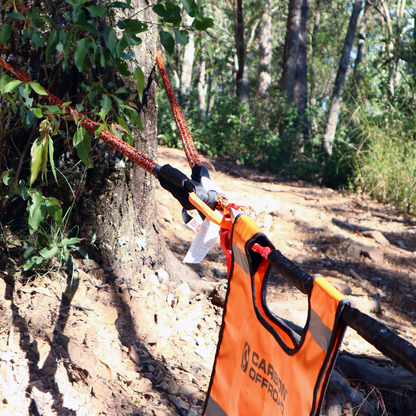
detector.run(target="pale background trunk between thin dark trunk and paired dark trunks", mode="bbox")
[257,0,272,103]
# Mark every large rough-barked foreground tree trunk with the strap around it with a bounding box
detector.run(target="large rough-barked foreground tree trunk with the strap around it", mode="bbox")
[79,0,164,283]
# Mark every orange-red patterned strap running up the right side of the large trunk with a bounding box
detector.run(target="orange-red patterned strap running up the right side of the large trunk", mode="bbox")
[156,51,201,169]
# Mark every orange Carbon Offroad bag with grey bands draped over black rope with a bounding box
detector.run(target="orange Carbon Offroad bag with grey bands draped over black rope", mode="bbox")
[203,215,347,416]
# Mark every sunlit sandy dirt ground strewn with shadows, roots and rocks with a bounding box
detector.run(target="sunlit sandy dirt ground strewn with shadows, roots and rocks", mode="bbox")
[0,148,416,416]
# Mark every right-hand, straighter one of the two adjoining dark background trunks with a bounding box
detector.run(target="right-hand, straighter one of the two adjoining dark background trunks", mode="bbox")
[293,0,310,142]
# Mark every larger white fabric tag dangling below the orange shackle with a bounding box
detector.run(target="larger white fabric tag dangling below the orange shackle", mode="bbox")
[183,218,220,264]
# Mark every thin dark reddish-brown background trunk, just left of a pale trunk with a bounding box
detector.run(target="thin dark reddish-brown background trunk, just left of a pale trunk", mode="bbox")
[235,0,249,103]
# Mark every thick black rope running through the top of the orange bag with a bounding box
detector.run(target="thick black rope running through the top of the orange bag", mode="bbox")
[267,250,416,375]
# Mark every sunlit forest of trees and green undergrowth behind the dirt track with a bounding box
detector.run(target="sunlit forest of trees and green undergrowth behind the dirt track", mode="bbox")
[158,0,416,211]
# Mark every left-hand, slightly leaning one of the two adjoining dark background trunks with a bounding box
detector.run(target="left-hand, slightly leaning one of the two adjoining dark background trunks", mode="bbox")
[282,0,303,104]
